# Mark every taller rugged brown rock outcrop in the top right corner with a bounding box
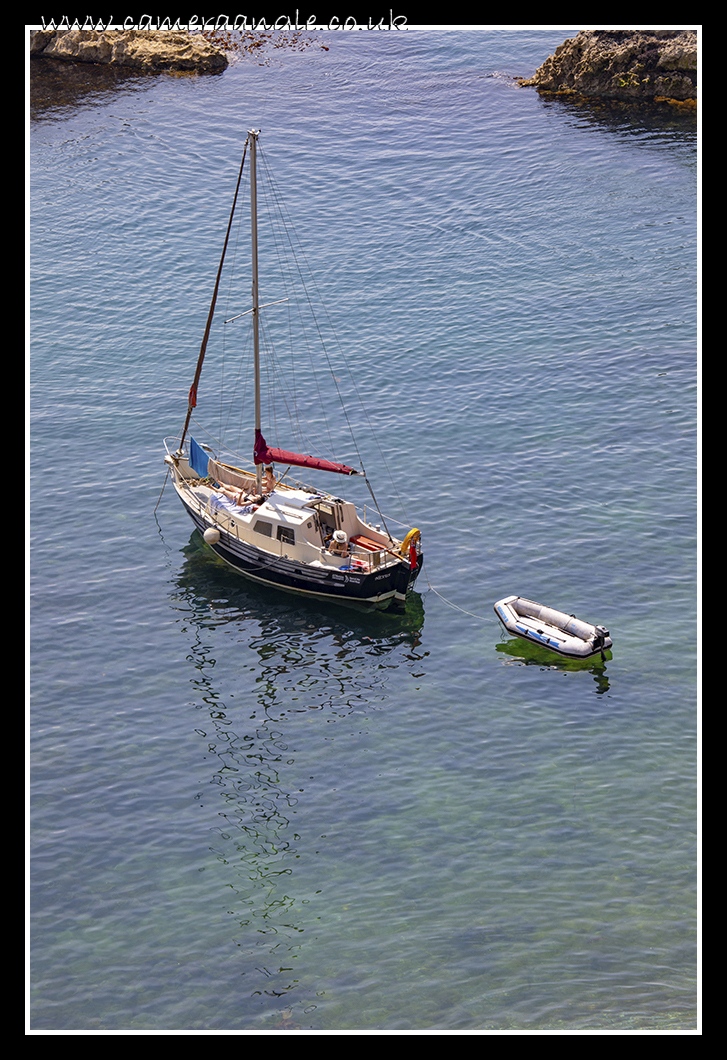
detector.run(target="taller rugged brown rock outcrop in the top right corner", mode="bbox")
[520,30,696,103]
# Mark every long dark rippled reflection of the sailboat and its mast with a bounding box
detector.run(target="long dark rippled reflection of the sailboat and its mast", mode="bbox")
[165,533,426,1018]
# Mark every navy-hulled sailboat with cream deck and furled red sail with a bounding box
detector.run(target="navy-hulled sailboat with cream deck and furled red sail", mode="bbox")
[164,130,424,608]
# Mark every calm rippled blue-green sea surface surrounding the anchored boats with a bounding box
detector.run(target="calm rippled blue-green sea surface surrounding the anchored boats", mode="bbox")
[30,30,697,1031]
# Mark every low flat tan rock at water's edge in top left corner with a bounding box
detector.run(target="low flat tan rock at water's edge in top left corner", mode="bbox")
[31,30,228,73]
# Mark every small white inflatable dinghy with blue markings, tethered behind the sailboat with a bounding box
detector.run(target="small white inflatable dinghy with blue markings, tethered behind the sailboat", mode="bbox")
[495,597,614,659]
